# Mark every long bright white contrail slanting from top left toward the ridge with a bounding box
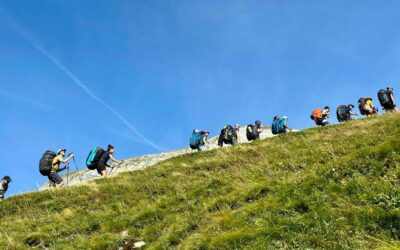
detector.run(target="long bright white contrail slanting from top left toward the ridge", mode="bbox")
[0,6,165,151]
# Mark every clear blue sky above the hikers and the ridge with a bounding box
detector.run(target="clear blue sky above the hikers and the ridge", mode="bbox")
[0,0,400,194]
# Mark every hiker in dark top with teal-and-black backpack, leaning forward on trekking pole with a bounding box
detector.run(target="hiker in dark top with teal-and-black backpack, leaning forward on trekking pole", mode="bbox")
[86,144,124,177]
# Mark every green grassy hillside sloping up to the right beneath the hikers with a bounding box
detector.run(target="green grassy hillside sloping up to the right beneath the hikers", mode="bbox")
[0,114,400,249]
